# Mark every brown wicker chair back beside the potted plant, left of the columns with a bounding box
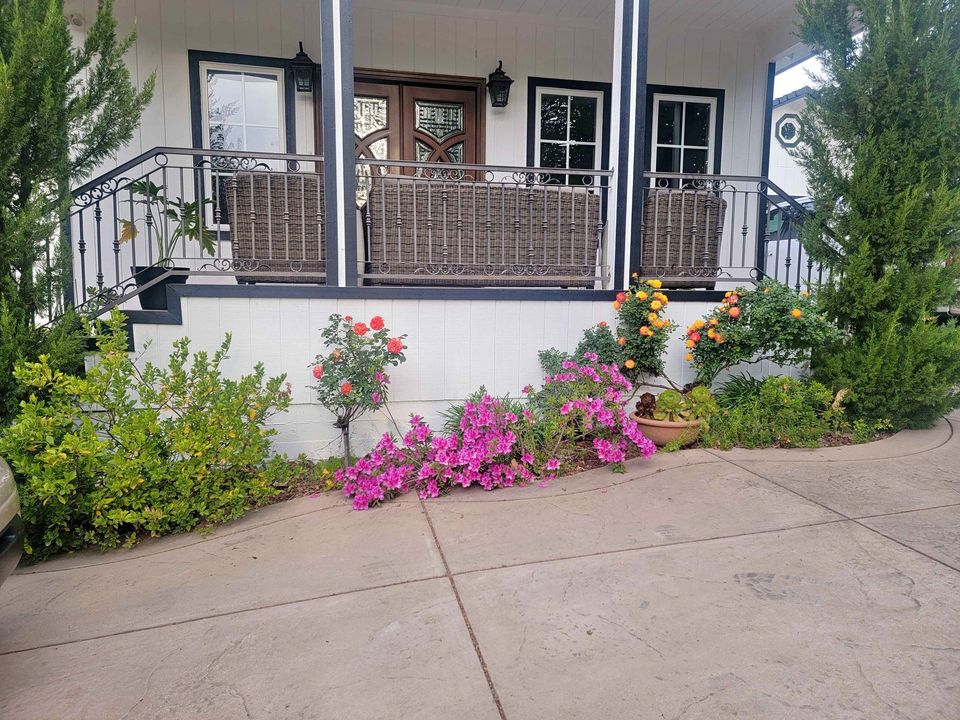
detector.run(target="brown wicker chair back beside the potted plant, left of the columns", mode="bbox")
[227,171,326,283]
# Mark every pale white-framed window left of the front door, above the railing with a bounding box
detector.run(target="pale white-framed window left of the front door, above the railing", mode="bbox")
[200,62,286,153]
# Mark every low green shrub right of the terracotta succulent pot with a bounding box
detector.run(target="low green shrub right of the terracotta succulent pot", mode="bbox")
[703,376,843,449]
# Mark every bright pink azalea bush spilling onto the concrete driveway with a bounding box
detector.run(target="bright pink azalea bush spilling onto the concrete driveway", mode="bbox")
[337,353,655,510]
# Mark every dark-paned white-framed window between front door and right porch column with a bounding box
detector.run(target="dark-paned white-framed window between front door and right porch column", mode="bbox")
[533,87,604,185]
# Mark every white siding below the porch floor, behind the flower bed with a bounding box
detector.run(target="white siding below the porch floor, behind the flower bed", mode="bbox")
[134,297,728,457]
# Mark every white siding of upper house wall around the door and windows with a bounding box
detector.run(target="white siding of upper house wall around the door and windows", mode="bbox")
[66,0,788,179]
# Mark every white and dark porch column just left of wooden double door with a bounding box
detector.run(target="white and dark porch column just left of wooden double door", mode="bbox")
[320,0,357,287]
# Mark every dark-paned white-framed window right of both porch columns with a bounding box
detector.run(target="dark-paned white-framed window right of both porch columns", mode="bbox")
[651,93,717,174]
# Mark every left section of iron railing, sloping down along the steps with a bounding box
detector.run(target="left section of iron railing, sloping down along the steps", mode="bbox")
[65,147,325,309]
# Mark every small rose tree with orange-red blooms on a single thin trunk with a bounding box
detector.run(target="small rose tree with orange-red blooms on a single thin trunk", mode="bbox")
[310,313,407,466]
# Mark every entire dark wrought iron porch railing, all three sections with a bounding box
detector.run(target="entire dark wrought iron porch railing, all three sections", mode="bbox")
[65,147,826,312]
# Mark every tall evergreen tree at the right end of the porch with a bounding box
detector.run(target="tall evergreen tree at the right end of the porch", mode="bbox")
[798,0,960,427]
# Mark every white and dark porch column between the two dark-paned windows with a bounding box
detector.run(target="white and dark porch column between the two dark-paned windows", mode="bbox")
[608,0,650,288]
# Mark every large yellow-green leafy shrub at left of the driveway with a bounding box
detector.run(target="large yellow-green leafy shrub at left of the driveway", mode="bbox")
[0,311,290,559]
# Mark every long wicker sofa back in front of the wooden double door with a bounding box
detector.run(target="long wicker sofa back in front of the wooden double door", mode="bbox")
[362,175,602,288]
